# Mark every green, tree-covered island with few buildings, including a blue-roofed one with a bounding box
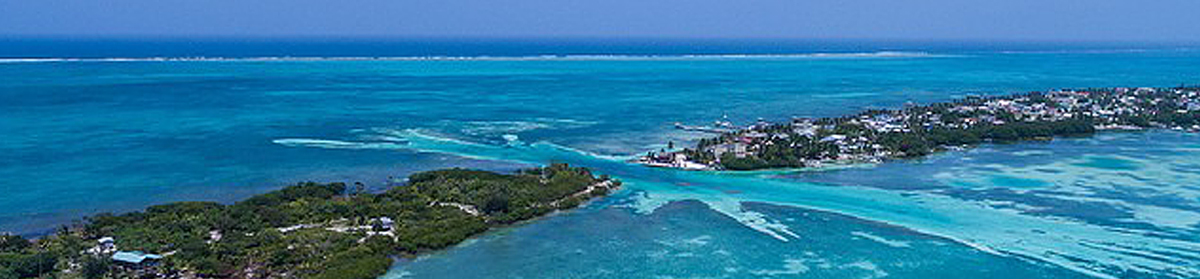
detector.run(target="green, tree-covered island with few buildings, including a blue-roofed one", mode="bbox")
[0,164,620,279]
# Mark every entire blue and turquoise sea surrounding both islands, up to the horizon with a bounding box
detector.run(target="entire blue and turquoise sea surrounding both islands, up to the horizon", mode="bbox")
[0,38,1200,279]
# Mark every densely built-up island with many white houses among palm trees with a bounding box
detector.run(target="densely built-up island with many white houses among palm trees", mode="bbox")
[635,87,1200,171]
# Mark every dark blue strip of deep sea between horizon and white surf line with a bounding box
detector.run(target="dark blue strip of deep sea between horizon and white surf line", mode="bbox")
[0,36,1200,59]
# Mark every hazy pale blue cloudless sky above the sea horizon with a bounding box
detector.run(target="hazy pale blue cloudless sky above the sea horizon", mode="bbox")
[0,0,1200,42]
